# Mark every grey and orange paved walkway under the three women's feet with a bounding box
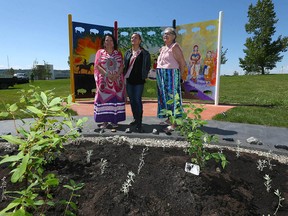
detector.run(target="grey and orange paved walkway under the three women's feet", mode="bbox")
[0,101,288,156]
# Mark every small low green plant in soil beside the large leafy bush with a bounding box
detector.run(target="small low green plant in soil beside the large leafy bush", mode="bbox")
[61,179,84,216]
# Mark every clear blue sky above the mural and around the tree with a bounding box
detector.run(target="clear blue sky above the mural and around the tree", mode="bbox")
[0,0,288,75]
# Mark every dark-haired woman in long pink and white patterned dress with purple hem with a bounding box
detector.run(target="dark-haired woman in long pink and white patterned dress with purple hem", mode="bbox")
[94,34,126,128]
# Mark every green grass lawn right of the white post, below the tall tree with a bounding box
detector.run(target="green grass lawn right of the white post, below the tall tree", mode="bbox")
[213,74,288,127]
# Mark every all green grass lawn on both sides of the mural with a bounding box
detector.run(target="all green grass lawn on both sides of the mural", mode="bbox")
[0,74,288,128]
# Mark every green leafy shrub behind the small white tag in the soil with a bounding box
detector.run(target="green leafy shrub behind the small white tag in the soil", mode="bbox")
[162,95,228,168]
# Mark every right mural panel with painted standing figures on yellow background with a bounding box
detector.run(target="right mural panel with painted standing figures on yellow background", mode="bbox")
[176,20,218,100]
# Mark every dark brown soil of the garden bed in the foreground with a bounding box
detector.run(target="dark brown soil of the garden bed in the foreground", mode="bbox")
[0,138,288,216]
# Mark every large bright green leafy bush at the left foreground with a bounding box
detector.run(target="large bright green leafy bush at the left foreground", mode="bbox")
[0,86,87,215]
